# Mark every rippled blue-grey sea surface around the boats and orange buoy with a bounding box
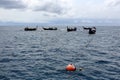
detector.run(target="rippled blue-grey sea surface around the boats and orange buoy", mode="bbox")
[0,27,120,80]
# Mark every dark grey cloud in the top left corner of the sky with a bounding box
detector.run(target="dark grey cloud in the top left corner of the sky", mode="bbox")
[0,0,26,9]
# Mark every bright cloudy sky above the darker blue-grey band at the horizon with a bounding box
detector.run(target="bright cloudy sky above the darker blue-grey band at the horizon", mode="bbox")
[0,0,120,23]
